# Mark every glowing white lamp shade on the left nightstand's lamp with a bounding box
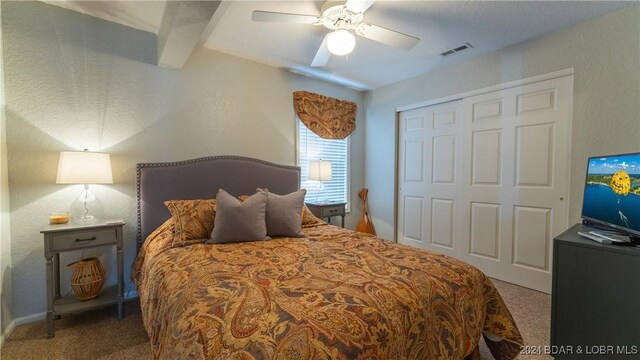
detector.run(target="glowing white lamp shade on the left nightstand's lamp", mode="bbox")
[56,151,113,184]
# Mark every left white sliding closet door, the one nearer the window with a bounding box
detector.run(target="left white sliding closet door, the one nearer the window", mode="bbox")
[397,101,462,256]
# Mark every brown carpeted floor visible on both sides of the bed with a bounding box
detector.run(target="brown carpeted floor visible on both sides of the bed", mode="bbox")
[0,280,551,360]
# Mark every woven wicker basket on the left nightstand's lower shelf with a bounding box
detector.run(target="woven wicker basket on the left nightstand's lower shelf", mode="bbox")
[67,258,106,300]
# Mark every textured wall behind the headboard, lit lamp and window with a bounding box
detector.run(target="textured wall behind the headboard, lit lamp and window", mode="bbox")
[2,2,364,317]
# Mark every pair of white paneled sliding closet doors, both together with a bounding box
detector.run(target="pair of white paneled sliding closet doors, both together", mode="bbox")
[397,76,573,293]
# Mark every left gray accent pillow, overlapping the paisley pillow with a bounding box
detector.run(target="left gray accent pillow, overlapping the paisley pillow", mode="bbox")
[207,189,268,244]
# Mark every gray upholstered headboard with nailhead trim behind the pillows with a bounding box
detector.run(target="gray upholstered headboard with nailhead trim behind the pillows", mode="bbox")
[137,156,300,247]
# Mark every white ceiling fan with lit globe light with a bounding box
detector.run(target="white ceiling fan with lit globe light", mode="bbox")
[252,0,420,66]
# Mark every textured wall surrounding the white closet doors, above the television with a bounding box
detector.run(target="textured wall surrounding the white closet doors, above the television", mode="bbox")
[365,7,640,239]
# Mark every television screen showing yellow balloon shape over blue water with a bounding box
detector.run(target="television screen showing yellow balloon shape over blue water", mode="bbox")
[582,153,640,235]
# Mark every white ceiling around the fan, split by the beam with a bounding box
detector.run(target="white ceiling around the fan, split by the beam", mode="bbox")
[40,0,638,89]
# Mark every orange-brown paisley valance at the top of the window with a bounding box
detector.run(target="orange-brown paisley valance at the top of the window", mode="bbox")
[293,91,358,139]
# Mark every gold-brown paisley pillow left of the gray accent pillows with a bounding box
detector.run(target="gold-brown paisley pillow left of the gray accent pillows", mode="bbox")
[164,199,216,247]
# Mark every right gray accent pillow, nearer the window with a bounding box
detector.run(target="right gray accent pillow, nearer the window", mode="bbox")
[266,189,307,237]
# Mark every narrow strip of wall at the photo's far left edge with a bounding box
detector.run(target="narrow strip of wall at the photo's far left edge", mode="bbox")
[0,0,13,338]
